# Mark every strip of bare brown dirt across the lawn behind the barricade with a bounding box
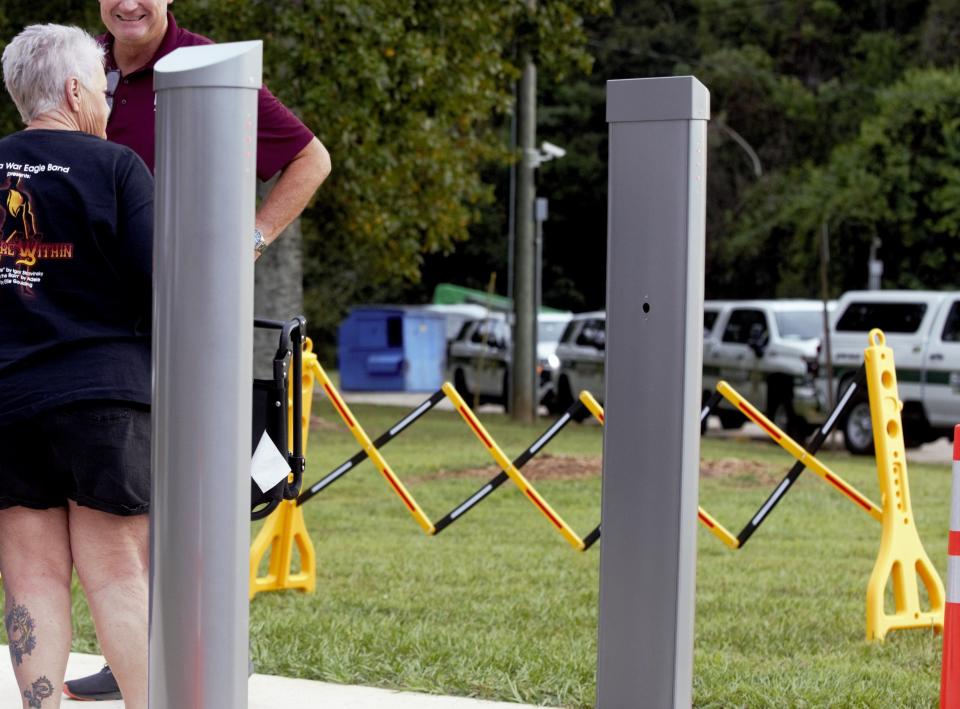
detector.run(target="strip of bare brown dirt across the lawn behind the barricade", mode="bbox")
[410,453,784,484]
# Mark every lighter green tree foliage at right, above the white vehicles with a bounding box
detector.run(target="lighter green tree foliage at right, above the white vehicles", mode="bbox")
[738,69,960,290]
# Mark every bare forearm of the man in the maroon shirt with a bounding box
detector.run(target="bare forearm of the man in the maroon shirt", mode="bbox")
[256,138,330,254]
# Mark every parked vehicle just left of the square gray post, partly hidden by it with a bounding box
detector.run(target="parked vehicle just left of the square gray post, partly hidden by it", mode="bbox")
[551,310,607,413]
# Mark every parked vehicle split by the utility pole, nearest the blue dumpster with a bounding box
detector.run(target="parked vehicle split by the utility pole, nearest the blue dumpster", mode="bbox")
[447,313,571,407]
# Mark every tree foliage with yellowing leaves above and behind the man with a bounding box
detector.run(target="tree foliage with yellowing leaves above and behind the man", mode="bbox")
[0,0,606,340]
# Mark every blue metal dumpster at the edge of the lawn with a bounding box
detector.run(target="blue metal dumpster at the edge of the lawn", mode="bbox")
[337,305,447,392]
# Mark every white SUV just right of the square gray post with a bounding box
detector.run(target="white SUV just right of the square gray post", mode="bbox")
[703,300,826,439]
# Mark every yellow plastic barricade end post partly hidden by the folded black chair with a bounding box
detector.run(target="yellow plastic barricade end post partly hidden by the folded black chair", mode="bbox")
[250,338,317,599]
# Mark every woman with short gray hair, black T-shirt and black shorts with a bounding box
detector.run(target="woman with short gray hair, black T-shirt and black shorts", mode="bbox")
[0,25,153,709]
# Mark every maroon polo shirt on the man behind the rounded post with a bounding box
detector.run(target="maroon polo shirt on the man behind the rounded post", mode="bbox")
[97,12,313,180]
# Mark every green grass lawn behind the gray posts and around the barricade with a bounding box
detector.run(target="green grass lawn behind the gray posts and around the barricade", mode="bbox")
[9,399,950,707]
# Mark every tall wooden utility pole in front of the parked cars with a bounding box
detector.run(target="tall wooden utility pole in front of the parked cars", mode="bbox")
[510,0,537,422]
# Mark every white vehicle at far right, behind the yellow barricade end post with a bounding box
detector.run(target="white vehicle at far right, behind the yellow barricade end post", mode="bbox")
[821,291,960,454]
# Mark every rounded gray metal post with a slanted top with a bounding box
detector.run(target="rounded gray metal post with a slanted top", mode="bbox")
[150,41,262,709]
